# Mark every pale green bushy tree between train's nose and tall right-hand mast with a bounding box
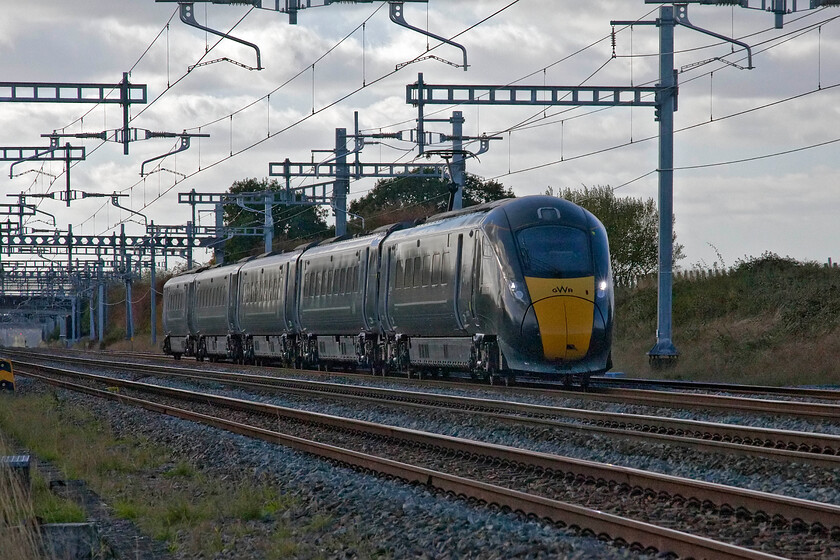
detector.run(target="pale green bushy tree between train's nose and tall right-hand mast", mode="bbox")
[546,186,685,284]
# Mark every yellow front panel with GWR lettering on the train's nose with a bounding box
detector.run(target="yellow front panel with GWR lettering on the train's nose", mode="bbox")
[525,276,595,360]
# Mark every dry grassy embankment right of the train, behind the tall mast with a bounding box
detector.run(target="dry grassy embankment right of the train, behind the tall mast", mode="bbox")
[613,253,840,385]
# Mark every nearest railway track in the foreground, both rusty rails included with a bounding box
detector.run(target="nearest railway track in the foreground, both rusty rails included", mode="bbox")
[18,365,840,558]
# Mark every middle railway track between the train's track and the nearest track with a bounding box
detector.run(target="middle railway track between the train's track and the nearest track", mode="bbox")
[6,358,840,468]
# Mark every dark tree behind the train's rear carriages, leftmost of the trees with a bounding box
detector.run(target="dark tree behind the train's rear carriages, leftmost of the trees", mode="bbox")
[224,178,335,262]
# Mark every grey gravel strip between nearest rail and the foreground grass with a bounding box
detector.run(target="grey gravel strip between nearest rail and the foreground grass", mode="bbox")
[13,379,639,559]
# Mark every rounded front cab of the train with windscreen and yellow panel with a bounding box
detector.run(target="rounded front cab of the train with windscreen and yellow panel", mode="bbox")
[496,197,613,385]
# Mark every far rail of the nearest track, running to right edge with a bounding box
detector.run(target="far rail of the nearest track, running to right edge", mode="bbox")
[16,365,840,530]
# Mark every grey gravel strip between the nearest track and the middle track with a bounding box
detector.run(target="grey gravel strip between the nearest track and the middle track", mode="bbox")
[120,372,840,505]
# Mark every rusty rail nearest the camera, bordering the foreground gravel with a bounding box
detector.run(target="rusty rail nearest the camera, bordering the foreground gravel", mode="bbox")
[14,372,782,560]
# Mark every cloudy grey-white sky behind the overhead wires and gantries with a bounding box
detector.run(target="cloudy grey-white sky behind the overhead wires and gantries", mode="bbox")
[0,0,840,269]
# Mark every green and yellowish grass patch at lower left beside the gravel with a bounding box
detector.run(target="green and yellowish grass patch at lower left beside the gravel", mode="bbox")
[0,394,378,559]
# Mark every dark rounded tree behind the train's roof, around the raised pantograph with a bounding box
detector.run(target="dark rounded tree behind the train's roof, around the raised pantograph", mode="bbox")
[349,173,516,230]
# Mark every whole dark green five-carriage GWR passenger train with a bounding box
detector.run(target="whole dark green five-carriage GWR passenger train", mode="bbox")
[163,196,614,385]
